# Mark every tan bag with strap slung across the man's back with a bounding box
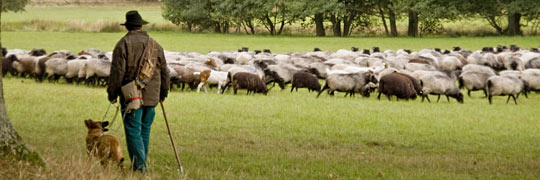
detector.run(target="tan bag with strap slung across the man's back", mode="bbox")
[122,37,158,113]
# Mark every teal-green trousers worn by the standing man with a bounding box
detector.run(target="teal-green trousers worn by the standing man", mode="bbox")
[122,106,156,173]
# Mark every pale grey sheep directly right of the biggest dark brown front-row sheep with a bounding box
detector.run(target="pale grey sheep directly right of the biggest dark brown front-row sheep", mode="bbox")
[420,73,463,103]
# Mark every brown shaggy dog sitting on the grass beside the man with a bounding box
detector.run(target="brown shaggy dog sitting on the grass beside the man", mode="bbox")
[84,119,124,168]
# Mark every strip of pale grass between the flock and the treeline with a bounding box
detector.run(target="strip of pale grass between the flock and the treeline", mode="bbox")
[2,32,540,54]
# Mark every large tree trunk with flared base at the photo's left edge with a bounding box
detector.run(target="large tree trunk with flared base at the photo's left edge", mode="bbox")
[0,8,46,166]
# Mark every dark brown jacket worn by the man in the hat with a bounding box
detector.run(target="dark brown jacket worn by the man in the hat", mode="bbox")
[107,30,170,106]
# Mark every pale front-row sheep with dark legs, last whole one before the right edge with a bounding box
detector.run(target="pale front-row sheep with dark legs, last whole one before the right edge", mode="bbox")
[486,76,527,104]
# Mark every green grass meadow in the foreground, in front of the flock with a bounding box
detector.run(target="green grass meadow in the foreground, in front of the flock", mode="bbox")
[0,74,540,179]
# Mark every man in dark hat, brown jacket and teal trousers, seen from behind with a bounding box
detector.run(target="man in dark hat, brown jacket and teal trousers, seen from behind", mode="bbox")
[107,11,169,172]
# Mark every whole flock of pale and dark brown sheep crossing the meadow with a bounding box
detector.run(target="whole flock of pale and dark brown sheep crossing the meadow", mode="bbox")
[2,45,540,104]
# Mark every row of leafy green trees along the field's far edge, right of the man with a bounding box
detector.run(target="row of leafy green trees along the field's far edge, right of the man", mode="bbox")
[163,0,540,37]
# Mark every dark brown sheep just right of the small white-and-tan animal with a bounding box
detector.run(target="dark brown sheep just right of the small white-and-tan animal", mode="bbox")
[232,72,268,95]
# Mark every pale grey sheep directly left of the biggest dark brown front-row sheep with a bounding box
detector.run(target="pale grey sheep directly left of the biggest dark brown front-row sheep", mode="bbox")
[317,72,377,97]
